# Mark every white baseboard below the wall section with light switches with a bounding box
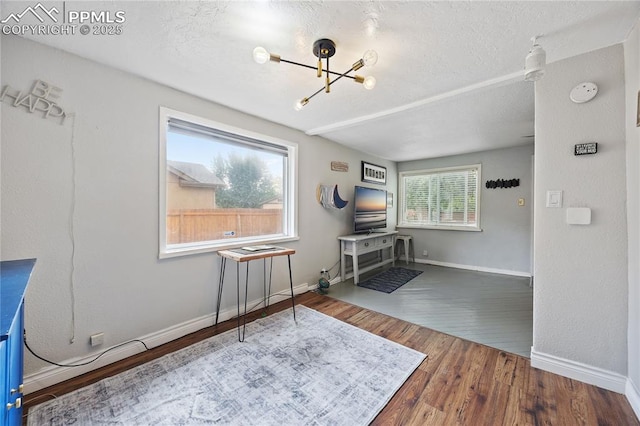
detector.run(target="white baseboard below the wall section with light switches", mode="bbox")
[531,347,628,394]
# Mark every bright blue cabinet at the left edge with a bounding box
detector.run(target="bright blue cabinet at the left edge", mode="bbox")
[0,259,36,425]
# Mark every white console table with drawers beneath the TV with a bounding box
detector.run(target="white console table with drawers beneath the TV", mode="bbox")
[338,231,398,285]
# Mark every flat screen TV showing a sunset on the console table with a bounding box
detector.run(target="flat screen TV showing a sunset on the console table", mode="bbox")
[353,186,387,233]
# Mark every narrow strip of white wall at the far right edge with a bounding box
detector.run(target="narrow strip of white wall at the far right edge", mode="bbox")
[624,21,640,417]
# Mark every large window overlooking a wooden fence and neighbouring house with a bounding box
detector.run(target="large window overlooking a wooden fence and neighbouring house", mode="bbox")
[160,108,297,257]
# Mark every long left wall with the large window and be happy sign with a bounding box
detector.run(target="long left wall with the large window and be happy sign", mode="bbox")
[1,36,397,384]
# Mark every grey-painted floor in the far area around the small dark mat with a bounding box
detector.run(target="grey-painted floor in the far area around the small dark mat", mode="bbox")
[329,261,533,357]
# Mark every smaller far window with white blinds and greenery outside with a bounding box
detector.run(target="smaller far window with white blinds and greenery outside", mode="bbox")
[398,164,481,231]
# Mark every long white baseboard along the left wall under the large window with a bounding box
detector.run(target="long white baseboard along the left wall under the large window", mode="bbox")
[24,283,309,394]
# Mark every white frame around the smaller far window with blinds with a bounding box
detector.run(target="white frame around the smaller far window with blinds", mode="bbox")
[397,164,482,232]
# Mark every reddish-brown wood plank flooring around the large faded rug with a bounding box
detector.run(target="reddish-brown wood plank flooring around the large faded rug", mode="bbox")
[24,292,640,426]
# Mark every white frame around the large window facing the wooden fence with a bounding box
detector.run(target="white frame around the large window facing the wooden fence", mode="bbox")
[158,106,300,259]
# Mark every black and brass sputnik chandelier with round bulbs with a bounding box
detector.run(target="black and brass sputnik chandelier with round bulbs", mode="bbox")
[253,38,378,111]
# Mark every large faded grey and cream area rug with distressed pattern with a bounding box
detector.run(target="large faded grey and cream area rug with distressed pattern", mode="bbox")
[27,305,425,426]
